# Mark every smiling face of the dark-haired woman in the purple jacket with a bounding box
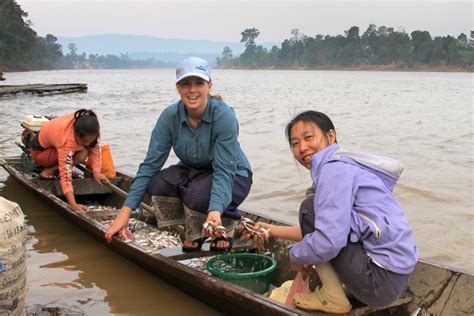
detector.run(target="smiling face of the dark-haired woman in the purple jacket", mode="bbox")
[290,121,336,169]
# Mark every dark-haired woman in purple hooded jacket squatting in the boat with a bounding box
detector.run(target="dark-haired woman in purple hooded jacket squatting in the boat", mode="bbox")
[252,111,418,313]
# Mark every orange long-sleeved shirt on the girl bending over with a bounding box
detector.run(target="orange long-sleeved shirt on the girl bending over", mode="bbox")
[38,113,100,194]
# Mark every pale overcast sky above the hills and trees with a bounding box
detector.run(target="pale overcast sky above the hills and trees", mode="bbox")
[17,0,474,43]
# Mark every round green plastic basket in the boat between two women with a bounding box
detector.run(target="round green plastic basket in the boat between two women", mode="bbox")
[206,253,276,294]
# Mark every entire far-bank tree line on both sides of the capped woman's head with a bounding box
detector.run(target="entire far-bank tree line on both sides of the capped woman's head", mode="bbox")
[0,0,474,71]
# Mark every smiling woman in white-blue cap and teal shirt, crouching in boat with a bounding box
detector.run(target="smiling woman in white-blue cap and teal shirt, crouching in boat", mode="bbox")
[105,57,252,251]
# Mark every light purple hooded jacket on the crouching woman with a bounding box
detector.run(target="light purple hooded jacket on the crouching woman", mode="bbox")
[290,144,418,274]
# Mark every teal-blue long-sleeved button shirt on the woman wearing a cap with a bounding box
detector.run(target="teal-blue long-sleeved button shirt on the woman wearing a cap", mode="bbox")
[124,97,251,213]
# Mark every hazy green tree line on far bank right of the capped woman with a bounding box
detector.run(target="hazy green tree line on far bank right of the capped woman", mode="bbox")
[217,24,474,70]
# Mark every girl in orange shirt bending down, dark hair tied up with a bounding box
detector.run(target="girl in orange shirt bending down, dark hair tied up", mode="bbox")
[30,109,106,211]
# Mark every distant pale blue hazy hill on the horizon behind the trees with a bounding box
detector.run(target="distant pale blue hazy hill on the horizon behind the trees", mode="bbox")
[58,34,279,63]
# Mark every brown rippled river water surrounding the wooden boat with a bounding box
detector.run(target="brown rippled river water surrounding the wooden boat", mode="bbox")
[0,69,474,315]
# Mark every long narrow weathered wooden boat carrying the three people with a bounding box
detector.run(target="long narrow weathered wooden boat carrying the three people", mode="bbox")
[0,156,474,315]
